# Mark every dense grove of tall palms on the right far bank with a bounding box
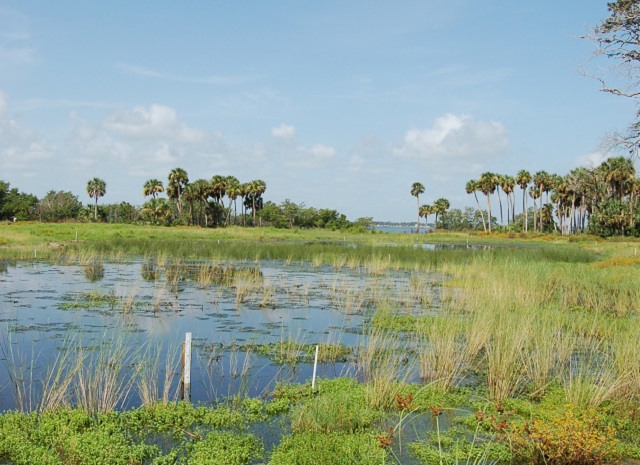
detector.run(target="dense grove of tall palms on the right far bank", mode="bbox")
[466,157,640,237]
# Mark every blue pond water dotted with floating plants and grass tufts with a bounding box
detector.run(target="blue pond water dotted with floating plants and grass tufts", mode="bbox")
[0,257,443,410]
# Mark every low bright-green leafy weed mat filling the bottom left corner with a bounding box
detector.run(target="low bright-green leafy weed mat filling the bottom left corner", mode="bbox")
[0,403,263,465]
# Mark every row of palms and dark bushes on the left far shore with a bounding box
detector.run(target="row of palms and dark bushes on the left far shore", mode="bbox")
[0,168,372,230]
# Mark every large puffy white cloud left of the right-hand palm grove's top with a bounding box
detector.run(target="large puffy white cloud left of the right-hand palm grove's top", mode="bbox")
[393,114,509,163]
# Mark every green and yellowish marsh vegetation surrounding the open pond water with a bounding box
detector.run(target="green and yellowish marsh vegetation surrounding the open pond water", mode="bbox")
[0,223,640,464]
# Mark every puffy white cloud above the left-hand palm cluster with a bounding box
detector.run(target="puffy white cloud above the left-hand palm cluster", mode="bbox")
[103,104,204,143]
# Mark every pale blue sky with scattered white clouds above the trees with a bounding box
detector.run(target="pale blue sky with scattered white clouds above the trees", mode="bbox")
[0,0,636,221]
